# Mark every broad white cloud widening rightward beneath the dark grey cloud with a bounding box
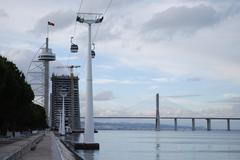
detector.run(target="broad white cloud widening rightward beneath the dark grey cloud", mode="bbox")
[99,13,240,83]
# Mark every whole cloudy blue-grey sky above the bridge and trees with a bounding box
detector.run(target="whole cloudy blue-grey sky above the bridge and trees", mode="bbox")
[0,0,240,117]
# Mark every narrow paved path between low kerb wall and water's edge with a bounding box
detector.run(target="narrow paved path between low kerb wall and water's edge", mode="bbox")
[22,132,62,160]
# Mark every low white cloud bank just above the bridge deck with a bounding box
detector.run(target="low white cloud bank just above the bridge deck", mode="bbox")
[94,97,240,117]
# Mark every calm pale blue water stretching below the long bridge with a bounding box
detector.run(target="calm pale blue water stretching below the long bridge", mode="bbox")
[66,130,240,160]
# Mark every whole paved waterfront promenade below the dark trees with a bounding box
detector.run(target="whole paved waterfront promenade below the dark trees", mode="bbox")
[0,132,76,160]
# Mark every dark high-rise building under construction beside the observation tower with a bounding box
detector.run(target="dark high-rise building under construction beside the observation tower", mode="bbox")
[51,74,80,130]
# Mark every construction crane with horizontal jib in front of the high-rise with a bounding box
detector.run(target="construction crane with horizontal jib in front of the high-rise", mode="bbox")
[56,65,81,130]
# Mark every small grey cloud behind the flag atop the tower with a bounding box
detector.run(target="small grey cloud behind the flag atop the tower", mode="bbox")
[31,10,76,35]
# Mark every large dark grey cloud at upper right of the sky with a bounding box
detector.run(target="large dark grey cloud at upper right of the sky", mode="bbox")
[142,5,221,38]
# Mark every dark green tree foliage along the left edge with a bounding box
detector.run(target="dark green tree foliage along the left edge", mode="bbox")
[0,56,46,133]
